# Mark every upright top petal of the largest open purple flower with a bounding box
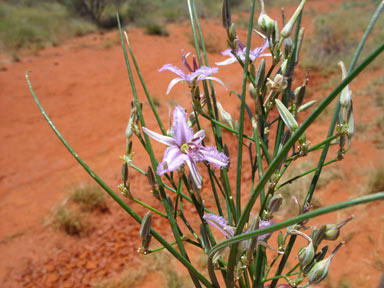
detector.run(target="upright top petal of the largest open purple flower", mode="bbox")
[172,106,193,147]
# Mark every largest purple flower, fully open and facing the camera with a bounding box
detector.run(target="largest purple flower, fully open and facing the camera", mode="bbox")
[143,106,229,189]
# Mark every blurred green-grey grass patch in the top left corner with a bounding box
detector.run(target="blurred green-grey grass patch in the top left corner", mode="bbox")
[0,2,96,53]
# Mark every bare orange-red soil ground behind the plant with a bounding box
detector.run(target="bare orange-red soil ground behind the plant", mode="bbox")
[0,2,384,287]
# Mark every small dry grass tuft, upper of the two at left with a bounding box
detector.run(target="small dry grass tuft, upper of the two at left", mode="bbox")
[69,183,109,212]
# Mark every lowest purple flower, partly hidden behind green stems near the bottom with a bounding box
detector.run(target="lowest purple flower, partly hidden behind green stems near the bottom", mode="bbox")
[203,214,275,241]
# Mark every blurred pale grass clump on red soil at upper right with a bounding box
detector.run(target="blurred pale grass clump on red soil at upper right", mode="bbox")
[301,0,384,75]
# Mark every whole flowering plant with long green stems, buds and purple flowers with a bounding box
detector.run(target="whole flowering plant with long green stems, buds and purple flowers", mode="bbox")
[27,0,384,288]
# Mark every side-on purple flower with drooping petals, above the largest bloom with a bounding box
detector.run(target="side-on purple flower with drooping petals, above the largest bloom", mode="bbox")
[159,53,225,94]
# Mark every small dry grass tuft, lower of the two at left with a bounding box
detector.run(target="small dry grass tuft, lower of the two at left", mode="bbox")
[50,205,86,236]
